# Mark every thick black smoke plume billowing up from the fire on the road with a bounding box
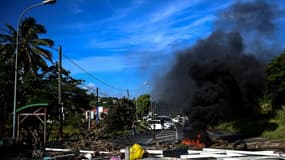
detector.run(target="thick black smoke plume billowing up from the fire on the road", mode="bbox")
[155,0,279,128]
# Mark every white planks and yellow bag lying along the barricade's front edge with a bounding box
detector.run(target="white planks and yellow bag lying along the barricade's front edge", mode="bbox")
[43,144,285,160]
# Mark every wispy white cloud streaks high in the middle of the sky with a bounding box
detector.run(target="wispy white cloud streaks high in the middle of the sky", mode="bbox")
[83,1,219,51]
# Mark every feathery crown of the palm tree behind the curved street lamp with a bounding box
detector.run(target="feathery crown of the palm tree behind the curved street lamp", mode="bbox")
[0,17,54,75]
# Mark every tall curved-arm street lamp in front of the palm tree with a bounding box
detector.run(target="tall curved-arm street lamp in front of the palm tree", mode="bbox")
[12,0,56,140]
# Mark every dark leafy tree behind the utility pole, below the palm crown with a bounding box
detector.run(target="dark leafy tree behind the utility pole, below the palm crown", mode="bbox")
[18,64,91,140]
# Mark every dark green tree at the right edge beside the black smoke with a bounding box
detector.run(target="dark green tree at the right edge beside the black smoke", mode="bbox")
[266,51,285,111]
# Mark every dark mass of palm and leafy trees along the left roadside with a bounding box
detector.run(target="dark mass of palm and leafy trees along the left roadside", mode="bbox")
[0,17,135,139]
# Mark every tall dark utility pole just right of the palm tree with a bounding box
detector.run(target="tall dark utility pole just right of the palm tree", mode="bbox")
[58,46,63,140]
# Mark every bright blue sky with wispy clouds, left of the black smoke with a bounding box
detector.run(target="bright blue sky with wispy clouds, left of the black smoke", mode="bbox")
[0,0,283,97]
